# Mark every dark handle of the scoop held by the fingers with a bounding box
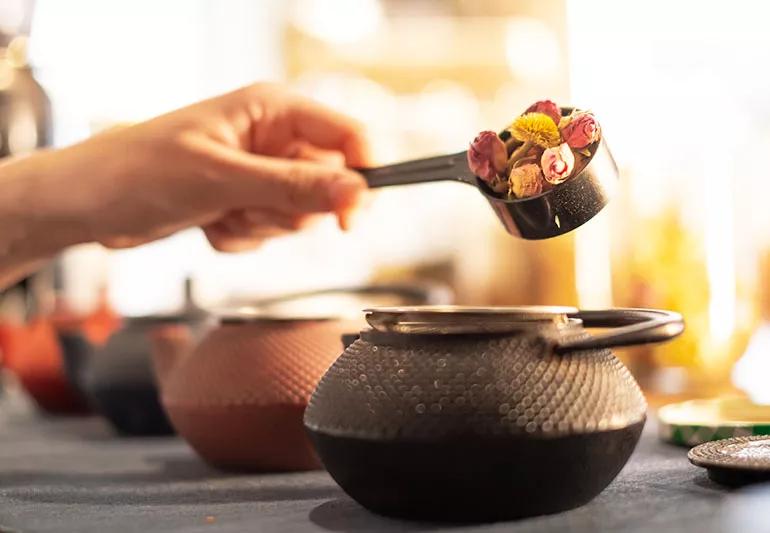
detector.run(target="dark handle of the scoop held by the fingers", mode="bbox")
[355,152,476,188]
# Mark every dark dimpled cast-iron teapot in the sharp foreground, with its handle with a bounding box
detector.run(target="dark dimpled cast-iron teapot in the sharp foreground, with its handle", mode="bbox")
[304,307,684,521]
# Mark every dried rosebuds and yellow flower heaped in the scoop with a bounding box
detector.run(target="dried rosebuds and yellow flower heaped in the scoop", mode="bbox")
[468,100,601,198]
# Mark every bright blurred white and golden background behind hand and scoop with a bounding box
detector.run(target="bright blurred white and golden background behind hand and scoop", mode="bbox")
[0,0,770,401]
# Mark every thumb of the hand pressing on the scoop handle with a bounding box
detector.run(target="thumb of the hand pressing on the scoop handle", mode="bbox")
[210,145,367,214]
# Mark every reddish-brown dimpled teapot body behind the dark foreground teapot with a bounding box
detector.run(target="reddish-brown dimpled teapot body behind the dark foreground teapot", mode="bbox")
[161,320,361,471]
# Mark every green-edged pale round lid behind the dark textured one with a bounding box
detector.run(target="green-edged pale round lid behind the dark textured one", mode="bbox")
[658,397,770,447]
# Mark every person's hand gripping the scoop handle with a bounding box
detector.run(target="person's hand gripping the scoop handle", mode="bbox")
[0,84,368,258]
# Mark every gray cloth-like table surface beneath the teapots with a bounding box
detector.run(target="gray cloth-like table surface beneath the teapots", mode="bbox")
[0,390,770,533]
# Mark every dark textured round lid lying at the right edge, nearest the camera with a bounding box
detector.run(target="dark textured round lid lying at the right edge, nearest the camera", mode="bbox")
[687,435,770,486]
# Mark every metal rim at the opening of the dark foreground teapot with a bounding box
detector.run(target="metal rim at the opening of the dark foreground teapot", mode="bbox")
[364,305,577,334]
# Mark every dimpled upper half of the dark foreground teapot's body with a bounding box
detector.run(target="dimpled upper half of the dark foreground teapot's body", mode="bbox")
[305,325,647,440]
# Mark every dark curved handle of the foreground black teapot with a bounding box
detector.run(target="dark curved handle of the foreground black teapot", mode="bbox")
[554,308,684,353]
